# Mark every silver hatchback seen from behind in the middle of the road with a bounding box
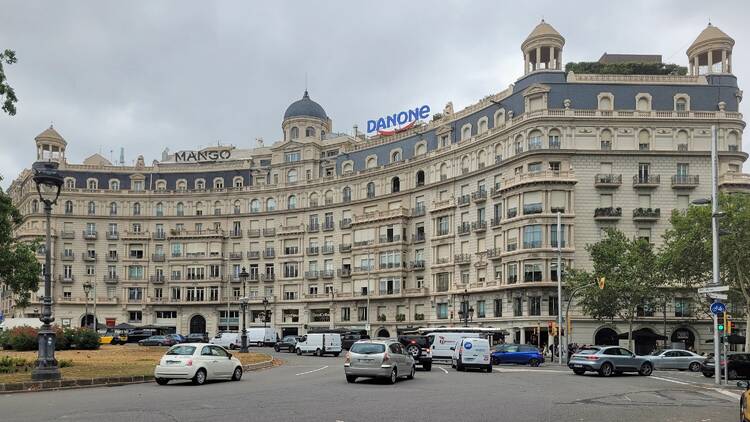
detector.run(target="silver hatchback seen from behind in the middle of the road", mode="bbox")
[344,340,416,384]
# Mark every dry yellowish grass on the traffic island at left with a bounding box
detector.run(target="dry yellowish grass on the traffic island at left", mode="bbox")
[0,344,270,383]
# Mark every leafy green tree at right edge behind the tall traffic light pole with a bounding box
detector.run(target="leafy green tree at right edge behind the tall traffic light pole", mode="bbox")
[661,193,750,350]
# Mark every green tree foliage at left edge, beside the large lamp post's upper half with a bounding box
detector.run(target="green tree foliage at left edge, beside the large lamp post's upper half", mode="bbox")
[0,177,42,308]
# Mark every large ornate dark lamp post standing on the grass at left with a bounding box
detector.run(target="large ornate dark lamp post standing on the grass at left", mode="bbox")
[31,161,63,381]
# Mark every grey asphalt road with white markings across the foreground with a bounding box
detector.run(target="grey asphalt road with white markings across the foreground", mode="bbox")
[0,351,739,422]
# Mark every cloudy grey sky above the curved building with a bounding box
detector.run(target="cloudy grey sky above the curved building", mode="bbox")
[0,0,750,187]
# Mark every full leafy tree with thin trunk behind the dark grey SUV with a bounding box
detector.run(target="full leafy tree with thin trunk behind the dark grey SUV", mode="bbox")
[567,229,662,350]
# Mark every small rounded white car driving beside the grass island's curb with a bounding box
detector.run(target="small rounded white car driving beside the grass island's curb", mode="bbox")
[154,343,242,385]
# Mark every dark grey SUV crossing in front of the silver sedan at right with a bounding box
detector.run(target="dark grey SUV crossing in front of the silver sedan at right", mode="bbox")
[568,346,654,377]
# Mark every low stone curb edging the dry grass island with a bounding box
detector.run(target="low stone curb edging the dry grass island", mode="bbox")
[0,358,274,394]
